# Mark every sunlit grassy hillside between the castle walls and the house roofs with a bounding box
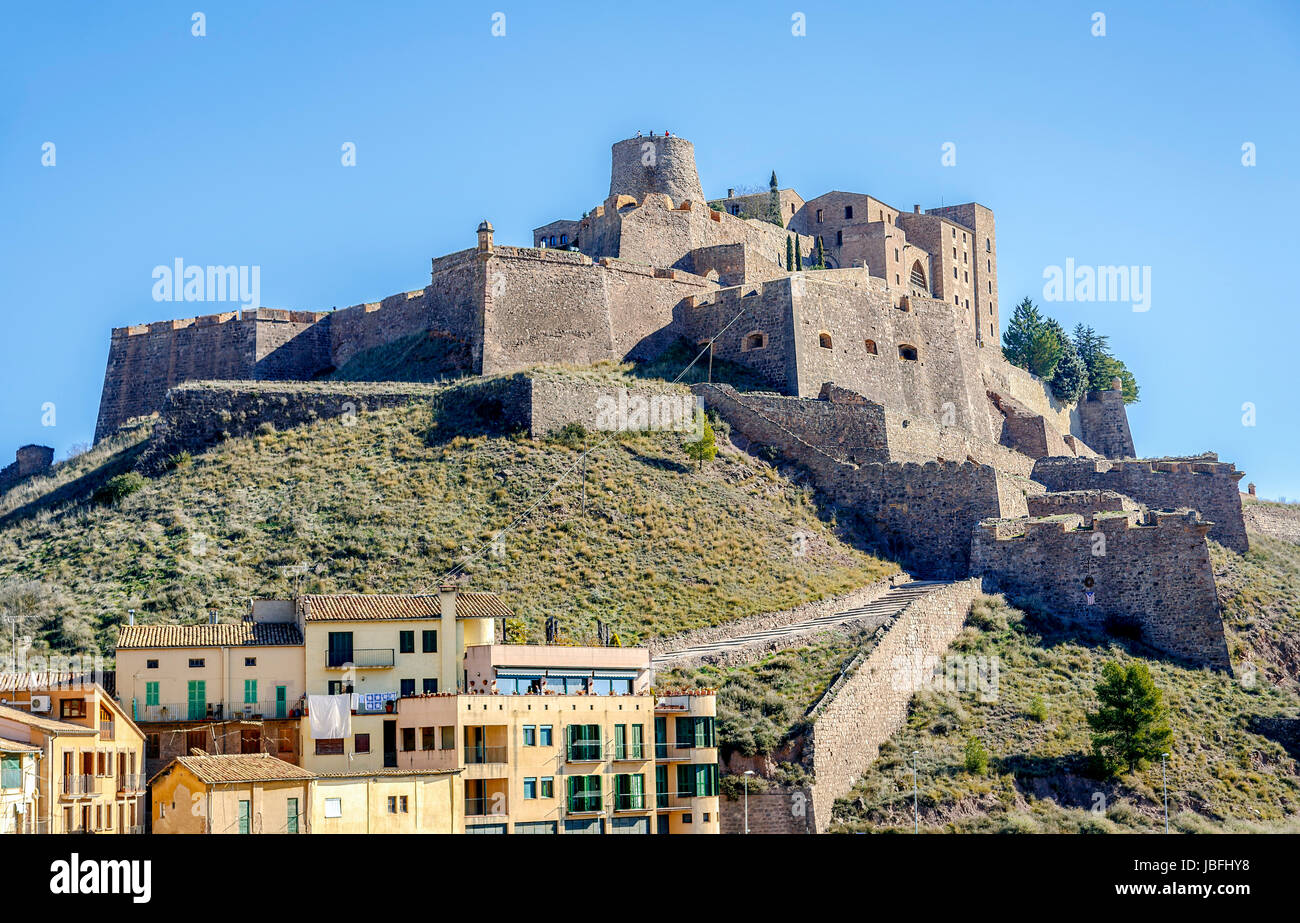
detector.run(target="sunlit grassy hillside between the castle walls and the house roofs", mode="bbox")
[0,390,897,650]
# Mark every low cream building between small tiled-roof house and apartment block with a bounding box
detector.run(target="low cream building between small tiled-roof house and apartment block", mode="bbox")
[311,770,464,833]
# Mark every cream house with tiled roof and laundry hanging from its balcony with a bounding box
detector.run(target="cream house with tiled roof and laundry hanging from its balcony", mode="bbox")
[295,588,514,774]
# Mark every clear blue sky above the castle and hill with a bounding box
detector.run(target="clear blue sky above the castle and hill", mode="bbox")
[0,0,1300,498]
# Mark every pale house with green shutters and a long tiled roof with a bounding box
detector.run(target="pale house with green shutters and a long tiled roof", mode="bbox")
[117,611,304,774]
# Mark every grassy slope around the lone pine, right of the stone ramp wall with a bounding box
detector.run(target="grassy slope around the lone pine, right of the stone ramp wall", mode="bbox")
[835,597,1300,832]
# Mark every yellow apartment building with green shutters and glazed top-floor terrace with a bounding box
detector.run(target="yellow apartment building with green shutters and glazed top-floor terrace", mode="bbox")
[397,645,719,835]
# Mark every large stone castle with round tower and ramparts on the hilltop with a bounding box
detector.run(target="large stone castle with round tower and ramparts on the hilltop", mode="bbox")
[86,137,1247,668]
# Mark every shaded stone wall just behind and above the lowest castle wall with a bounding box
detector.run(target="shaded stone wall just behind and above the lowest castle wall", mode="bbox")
[1034,456,1249,554]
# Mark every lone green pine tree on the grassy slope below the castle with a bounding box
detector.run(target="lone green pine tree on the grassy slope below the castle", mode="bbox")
[1087,662,1173,775]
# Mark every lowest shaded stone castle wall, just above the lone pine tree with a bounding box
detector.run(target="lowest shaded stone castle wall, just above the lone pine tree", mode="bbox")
[971,510,1231,670]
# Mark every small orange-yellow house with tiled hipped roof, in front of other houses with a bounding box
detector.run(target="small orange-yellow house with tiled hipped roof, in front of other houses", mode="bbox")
[150,753,313,833]
